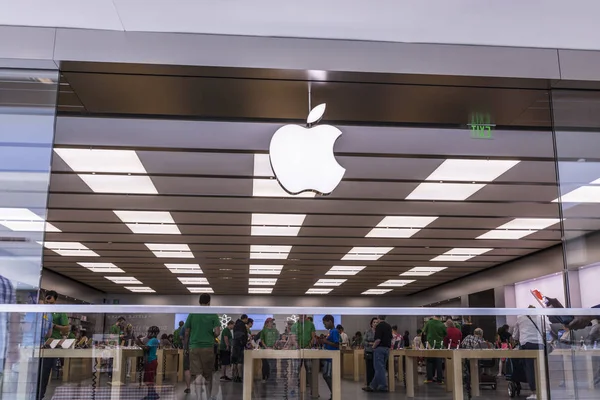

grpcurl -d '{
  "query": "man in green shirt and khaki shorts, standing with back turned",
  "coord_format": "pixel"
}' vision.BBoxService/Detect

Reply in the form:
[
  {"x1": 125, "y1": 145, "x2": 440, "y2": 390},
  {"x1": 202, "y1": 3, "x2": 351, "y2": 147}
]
[{"x1": 183, "y1": 293, "x2": 221, "y2": 398}]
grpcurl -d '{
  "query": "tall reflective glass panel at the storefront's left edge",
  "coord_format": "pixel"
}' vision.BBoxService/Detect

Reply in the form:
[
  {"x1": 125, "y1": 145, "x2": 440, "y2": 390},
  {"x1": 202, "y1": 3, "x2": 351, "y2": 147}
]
[{"x1": 0, "y1": 69, "x2": 58, "y2": 399}]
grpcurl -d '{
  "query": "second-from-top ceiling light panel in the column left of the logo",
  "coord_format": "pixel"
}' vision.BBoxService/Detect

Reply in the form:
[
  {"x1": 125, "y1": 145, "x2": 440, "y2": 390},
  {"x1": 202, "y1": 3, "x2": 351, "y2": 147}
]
[{"x1": 79, "y1": 174, "x2": 158, "y2": 194}]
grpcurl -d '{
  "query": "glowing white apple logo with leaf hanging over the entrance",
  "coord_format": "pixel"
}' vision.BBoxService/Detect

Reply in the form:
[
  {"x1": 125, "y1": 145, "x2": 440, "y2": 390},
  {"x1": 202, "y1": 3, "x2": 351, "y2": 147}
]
[{"x1": 269, "y1": 104, "x2": 346, "y2": 195}]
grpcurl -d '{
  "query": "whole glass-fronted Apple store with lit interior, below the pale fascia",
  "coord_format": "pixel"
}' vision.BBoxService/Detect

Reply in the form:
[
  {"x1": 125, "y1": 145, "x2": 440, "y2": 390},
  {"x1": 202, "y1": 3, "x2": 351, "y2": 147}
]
[{"x1": 0, "y1": 62, "x2": 600, "y2": 400}]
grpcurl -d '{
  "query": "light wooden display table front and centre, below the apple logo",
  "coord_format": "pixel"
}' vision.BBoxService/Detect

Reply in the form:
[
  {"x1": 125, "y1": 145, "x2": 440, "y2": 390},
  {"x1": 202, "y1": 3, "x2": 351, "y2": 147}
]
[{"x1": 243, "y1": 349, "x2": 342, "y2": 400}]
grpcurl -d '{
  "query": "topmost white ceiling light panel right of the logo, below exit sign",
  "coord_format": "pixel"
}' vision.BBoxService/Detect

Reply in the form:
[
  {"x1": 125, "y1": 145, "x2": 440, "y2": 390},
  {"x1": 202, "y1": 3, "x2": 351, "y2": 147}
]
[{"x1": 425, "y1": 159, "x2": 519, "y2": 182}]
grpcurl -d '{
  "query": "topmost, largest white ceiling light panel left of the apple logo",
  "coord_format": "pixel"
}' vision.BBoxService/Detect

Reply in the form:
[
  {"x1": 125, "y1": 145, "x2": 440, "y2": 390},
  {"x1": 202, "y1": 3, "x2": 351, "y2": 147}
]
[{"x1": 54, "y1": 148, "x2": 147, "y2": 174}]
